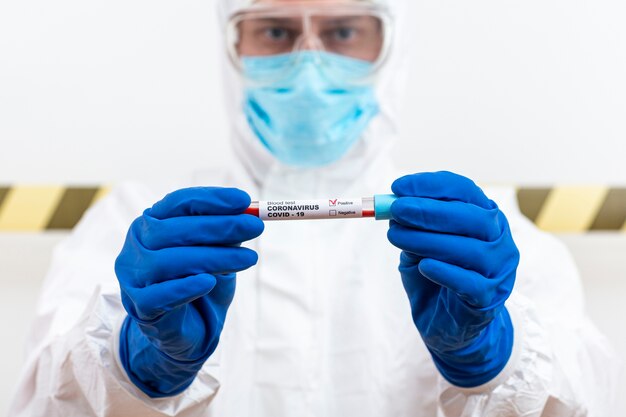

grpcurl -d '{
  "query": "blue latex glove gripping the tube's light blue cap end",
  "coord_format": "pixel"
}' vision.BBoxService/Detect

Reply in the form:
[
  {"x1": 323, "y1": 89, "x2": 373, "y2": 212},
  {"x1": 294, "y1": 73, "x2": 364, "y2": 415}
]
[{"x1": 388, "y1": 172, "x2": 519, "y2": 387}]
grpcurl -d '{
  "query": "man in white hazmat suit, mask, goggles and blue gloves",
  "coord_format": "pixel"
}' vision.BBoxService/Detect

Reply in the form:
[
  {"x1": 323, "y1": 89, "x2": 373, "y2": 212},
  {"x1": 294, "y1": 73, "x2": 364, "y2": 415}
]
[{"x1": 11, "y1": 0, "x2": 613, "y2": 416}]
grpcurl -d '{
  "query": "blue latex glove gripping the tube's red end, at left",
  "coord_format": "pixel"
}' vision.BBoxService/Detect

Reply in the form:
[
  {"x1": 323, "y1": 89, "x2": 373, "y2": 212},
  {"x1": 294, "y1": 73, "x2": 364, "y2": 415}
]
[{"x1": 115, "y1": 188, "x2": 263, "y2": 397}]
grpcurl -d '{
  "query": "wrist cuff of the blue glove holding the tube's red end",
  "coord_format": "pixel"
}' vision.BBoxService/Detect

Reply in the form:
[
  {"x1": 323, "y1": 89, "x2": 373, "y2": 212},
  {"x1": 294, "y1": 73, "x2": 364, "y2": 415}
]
[{"x1": 119, "y1": 316, "x2": 213, "y2": 398}]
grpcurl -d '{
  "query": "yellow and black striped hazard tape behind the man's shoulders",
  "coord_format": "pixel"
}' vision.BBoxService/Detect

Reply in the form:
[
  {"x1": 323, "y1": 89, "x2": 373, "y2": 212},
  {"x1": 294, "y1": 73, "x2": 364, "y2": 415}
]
[{"x1": 0, "y1": 186, "x2": 626, "y2": 233}]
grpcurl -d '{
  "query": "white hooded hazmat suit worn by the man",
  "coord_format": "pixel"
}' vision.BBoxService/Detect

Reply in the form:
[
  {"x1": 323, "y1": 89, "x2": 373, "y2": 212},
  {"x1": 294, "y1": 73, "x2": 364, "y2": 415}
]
[{"x1": 10, "y1": 0, "x2": 616, "y2": 417}]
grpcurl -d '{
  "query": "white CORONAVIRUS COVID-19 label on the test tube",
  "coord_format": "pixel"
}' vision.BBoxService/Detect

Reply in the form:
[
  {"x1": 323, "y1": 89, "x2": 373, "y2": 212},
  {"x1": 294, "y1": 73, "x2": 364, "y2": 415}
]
[{"x1": 259, "y1": 197, "x2": 363, "y2": 220}]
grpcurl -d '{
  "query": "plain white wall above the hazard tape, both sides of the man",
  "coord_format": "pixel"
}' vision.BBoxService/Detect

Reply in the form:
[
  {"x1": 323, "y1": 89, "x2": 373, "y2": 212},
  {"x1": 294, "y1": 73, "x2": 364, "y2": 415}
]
[{"x1": 0, "y1": 0, "x2": 626, "y2": 184}]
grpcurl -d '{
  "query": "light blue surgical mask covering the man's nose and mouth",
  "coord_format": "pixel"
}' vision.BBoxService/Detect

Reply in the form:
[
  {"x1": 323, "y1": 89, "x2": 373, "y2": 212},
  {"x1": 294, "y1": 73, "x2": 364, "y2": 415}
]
[{"x1": 243, "y1": 51, "x2": 379, "y2": 167}]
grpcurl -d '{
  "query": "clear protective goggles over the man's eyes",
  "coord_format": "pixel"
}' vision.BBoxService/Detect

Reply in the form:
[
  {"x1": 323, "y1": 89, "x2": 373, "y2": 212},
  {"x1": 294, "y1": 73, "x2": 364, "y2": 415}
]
[{"x1": 226, "y1": 1, "x2": 391, "y2": 82}]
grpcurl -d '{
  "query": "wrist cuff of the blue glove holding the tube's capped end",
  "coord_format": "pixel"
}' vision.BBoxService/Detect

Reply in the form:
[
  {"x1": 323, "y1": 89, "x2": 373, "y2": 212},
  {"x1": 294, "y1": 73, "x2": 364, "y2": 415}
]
[{"x1": 428, "y1": 308, "x2": 514, "y2": 388}]
